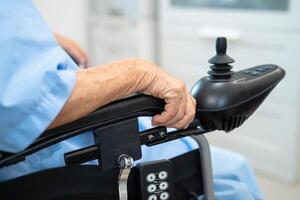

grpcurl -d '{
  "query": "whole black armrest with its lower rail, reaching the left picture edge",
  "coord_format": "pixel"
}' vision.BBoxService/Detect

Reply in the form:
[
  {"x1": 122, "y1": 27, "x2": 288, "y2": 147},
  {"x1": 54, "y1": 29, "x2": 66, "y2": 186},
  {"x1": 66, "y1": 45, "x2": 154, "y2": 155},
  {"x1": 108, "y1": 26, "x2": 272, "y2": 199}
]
[{"x1": 0, "y1": 94, "x2": 165, "y2": 168}]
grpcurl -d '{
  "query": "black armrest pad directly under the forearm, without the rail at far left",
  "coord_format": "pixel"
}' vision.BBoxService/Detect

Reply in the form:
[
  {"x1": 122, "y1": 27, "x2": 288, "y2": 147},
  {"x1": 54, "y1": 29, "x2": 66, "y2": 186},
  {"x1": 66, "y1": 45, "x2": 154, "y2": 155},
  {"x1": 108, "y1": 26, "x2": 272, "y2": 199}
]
[{"x1": 33, "y1": 94, "x2": 165, "y2": 145}]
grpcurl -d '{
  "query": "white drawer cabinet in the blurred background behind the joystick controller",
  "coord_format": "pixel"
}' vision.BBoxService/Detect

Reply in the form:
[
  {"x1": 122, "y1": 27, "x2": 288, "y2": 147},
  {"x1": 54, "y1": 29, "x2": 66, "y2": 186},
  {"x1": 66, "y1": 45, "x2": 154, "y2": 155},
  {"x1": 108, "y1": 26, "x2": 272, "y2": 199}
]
[{"x1": 160, "y1": 0, "x2": 300, "y2": 182}]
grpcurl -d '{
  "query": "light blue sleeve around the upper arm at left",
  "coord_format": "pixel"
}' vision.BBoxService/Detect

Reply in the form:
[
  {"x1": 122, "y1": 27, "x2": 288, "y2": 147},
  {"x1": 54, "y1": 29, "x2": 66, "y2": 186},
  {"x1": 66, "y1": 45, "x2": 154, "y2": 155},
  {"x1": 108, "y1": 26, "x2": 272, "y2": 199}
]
[{"x1": 0, "y1": 0, "x2": 77, "y2": 152}]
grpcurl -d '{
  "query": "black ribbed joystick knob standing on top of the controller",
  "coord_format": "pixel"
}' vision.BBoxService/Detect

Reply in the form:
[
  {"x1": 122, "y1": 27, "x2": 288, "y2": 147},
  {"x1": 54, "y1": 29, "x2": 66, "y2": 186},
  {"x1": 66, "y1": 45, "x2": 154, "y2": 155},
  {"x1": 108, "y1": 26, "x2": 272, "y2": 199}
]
[{"x1": 208, "y1": 37, "x2": 234, "y2": 79}]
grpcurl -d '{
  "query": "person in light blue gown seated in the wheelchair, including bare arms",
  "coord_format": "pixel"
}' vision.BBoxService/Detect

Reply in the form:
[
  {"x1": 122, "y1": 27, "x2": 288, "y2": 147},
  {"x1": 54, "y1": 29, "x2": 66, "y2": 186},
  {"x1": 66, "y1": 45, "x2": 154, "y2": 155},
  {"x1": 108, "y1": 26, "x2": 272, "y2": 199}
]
[{"x1": 0, "y1": 0, "x2": 259, "y2": 199}]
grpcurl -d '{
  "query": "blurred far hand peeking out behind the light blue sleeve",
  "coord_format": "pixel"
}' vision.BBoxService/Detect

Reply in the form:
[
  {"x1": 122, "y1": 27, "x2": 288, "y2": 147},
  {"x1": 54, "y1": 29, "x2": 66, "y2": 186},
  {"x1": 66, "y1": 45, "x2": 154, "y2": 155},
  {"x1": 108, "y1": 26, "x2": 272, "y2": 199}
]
[{"x1": 54, "y1": 33, "x2": 89, "y2": 68}]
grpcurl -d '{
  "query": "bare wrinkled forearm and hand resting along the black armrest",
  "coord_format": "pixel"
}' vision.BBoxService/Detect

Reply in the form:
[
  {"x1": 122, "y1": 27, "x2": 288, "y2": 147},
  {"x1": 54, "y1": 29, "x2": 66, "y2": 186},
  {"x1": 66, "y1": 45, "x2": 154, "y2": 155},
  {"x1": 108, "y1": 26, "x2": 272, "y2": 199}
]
[{"x1": 49, "y1": 59, "x2": 196, "y2": 129}]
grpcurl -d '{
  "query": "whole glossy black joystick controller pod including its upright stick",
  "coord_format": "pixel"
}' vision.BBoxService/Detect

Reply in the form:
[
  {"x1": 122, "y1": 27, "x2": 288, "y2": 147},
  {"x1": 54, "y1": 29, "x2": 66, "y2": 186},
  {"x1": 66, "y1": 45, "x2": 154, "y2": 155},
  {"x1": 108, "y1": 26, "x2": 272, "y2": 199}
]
[{"x1": 191, "y1": 37, "x2": 285, "y2": 132}]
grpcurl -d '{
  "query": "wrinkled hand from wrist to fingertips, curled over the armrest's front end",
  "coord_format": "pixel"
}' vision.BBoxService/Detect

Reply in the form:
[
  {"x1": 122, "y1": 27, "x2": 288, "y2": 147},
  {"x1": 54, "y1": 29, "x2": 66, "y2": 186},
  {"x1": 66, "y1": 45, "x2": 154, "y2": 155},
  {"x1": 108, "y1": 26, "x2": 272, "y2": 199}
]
[{"x1": 139, "y1": 60, "x2": 196, "y2": 129}]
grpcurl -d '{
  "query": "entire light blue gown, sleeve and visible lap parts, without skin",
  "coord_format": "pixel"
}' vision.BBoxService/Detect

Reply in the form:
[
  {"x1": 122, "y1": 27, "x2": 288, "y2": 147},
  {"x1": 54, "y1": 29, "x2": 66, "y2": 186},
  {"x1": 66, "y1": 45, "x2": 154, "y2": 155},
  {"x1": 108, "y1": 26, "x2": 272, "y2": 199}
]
[{"x1": 0, "y1": 0, "x2": 261, "y2": 200}]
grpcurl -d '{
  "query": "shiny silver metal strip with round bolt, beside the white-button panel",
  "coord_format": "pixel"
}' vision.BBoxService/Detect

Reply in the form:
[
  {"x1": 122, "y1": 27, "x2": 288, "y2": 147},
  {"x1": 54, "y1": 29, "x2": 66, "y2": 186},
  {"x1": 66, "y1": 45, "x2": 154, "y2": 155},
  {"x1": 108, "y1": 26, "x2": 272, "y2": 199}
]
[{"x1": 118, "y1": 154, "x2": 133, "y2": 200}]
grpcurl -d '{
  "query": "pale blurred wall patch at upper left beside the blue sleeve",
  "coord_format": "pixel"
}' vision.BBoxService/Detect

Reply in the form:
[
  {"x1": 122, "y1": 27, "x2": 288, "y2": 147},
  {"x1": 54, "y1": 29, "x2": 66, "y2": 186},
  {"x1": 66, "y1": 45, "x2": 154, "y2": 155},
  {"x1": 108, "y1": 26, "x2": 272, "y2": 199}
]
[{"x1": 33, "y1": 0, "x2": 89, "y2": 49}]
